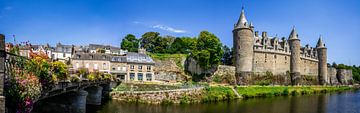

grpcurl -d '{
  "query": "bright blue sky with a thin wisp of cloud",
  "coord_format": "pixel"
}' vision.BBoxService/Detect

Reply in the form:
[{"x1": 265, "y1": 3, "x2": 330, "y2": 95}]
[{"x1": 0, "y1": 0, "x2": 360, "y2": 65}]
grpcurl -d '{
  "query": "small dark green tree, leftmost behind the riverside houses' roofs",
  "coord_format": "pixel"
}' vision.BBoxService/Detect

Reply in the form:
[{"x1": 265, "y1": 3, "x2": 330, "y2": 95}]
[{"x1": 120, "y1": 34, "x2": 139, "y2": 52}]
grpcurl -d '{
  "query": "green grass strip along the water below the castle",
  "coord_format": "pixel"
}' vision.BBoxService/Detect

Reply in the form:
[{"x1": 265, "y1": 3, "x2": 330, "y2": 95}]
[{"x1": 236, "y1": 86, "x2": 351, "y2": 98}]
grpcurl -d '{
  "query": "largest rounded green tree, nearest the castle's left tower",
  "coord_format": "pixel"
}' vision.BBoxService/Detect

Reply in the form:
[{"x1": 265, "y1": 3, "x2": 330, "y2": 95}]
[{"x1": 191, "y1": 31, "x2": 223, "y2": 69}]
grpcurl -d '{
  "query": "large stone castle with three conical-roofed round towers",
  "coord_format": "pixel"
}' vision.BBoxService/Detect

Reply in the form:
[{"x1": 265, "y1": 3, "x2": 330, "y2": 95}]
[{"x1": 233, "y1": 9, "x2": 328, "y2": 85}]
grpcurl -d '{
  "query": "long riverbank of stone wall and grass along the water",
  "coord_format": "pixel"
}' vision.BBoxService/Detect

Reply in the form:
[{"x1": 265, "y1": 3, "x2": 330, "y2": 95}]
[{"x1": 110, "y1": 86, "x2": 354, "y2": 104}]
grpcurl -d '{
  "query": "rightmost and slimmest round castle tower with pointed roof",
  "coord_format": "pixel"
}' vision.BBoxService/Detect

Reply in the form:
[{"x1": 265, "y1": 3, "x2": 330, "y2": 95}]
[{"x1": 316, "y1": 35, "x2": 328, "y2": 85}]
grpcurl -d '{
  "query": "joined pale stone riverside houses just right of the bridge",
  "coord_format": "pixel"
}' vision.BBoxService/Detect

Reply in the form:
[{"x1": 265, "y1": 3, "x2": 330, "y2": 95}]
[{"x1": 71, "y1": 50, "x2": 155, "y2": 82}]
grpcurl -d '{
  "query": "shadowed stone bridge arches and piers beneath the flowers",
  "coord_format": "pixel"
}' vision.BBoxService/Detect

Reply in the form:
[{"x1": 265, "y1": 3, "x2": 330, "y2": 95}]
[{"x1": 34, "y1": 81, "x2": 117, "y2": 113}]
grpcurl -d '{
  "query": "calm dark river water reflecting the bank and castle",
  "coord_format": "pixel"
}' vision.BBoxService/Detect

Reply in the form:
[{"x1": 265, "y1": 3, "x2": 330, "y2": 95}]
[{"x1": 87, "y1": 91, "x2": 360, "y2": 113}]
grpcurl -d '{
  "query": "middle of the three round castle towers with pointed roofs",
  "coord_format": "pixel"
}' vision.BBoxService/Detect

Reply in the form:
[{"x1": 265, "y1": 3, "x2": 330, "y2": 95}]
[{"x1": 288, "y1": 27, "x2": 301, "y2": 85}]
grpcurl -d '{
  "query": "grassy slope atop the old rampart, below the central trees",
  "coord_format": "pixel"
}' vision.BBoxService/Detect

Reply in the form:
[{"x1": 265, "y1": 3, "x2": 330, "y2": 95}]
[{"x1": 149, "y1": 53, "x2": 188, "y2": 69}]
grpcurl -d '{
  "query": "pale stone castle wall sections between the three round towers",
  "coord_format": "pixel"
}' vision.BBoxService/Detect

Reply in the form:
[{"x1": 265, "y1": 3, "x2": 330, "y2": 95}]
[{"x1": 253, "y1": 50, "x2": 318, "y2": 76}]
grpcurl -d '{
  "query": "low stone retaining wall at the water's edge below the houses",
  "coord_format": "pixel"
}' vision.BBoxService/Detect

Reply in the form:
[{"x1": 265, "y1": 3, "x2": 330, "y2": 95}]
[{"x1": 110, "y1": 88, "x2": 203, "y2": 104}]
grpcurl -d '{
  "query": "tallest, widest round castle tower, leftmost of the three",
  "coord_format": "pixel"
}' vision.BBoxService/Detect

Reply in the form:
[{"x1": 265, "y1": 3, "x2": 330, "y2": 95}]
[{"x1": 233, "y1": 8, "x2": 254, "y2": 85}]
